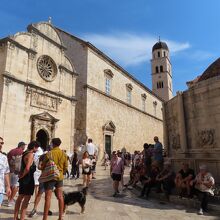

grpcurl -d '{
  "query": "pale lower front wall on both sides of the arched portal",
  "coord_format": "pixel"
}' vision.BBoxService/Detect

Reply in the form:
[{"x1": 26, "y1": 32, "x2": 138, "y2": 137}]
[{"x1": 0, "y1": 81, "x2": 75, "y2": 152}]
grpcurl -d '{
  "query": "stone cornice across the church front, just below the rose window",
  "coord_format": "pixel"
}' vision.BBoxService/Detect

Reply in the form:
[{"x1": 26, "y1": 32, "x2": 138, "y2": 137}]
[{"x1": 2, "y1": 72, "x2": 77, "y2": 102}]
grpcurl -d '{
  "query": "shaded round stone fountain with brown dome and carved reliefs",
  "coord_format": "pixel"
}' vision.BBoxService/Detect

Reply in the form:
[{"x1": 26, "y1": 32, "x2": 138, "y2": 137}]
[{"x1": 164, "y1": 59, "x2": 220, "y2": 182}]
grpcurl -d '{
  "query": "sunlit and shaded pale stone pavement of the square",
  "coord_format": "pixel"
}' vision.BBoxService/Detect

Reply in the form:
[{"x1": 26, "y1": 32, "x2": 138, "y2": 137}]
[{"x1": 0, "y1": 166, "x2": 220, "y2": 220}]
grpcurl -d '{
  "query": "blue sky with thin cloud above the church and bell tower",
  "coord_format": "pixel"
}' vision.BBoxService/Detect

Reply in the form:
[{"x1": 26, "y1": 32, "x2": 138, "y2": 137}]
[{"x1": 0, "y1": 0, "x2": 220, "y2": 94}]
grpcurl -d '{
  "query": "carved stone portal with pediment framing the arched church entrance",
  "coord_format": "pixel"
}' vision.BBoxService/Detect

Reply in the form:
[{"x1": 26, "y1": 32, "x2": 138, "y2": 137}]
[{"x1": 31, "y1": 112, "x2": 59, "y2": 143}]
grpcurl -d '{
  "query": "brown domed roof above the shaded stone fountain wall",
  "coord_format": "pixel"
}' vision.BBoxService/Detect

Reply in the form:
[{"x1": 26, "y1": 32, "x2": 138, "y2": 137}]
[{"x1": 198, "y1": 58, "x2": 220, "y2": 82}]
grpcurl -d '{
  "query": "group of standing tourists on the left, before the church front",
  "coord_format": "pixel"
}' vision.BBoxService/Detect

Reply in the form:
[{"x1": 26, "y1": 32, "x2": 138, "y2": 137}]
[{"x1": 0, "y1": 137, "x2": 97, "y2": 220}]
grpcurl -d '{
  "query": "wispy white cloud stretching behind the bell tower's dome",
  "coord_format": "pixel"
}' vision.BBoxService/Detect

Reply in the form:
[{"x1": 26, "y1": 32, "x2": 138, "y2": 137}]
[{"x1": 82, "y1": 32, "x2": 190, "y2": 66}]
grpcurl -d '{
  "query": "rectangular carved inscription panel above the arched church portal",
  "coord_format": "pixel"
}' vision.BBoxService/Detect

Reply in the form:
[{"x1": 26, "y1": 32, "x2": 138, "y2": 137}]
[{"x1": 31, "y1": 90, "x2": 62, "y2": 112}]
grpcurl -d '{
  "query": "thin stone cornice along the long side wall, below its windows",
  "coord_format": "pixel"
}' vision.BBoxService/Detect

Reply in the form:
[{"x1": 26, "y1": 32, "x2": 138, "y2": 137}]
[{"x1": 84, "y1": 84, "x2": 163, "y2": 122}]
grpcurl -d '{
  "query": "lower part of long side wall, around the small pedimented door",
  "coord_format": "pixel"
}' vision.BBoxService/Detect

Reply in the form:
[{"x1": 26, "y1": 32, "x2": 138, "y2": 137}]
[{"x1": 87, "y1": 88, "x2": 163, "y2": 160}]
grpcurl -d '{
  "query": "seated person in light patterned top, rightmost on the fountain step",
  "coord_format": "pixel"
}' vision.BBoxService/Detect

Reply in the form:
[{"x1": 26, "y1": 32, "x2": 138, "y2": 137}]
[{"x1": 191, "y1": 165, "x2": 215, "y2": 215}]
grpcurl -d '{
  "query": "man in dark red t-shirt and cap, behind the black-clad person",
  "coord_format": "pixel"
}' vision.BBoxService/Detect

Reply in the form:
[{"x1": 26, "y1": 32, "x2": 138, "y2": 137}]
[{"x1": 7, "y1": 141, "x2": 26, "y2": 207}]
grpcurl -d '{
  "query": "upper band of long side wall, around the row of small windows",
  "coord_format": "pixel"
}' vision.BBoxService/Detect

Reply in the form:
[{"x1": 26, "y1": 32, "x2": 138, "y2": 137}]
[{"x1": 87, "y1": 49, "x2": 162, "y2": 120}]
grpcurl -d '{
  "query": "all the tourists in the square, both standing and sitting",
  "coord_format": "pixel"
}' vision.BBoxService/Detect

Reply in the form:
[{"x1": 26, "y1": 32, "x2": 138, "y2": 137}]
[{"x1": 0, "y1": 137, "x2": 215, "y2": 220}]
